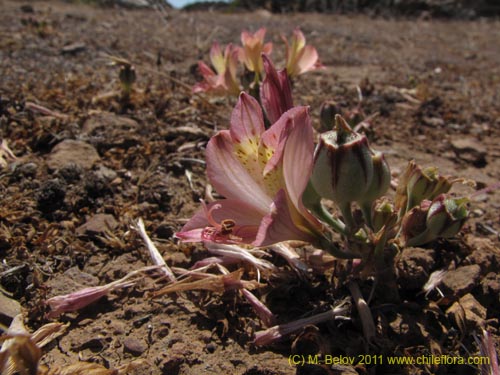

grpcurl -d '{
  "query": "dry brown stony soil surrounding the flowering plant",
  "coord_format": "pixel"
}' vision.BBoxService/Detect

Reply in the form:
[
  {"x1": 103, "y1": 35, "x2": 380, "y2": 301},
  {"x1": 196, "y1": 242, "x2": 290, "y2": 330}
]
[{"x1": 0, "y1": 0, "x2": 500, "y2": 375}]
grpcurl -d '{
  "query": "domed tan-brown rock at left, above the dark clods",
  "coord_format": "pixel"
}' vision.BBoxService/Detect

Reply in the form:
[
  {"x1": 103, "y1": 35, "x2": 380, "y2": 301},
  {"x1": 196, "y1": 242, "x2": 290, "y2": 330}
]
[{"x1": 47, "y1": 139, "x2": 100, "y2": 170}]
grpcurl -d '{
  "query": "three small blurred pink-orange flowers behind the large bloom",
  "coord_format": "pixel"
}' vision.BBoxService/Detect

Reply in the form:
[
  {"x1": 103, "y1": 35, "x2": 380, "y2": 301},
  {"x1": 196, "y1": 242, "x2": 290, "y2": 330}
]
[{"x1": 193, "y1": 28, "x2": 322, "y2": 95}]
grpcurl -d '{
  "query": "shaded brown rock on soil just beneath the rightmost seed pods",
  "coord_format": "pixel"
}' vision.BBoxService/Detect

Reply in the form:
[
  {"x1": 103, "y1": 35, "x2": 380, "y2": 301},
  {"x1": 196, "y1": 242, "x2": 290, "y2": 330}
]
[{"x1": 396, "y1": 247, "x2": 436, "y2": 290}]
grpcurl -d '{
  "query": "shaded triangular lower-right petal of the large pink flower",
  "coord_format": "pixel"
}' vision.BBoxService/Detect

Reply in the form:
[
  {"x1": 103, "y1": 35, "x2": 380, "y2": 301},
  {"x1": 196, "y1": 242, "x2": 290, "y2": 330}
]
[{"x1": 253, "y1": 189, "x2": 312, "y2": 246}]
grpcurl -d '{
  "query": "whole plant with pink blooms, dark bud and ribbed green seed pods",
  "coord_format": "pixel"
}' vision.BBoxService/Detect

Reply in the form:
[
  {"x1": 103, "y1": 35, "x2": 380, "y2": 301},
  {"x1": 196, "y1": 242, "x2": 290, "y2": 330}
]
[{"x1": 180, "y1": 25, "x2": 468, "y2": 268}]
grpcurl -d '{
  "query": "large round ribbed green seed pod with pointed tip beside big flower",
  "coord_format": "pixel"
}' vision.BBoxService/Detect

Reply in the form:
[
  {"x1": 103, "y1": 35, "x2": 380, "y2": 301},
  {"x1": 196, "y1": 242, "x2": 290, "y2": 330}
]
[{"x1": 311, "y1": 115, "x2": 373, "y2": 205}]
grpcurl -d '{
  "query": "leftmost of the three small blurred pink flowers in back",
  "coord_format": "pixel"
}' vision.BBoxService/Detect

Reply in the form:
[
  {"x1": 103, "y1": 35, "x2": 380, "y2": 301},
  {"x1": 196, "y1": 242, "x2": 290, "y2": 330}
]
[{"x1": 193, "y1": 42, "x2": 240, "y2": 95}]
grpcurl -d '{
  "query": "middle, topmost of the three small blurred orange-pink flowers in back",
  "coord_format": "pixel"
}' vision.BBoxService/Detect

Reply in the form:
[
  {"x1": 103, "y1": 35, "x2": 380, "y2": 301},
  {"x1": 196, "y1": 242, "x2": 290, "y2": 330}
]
[{"x1": 239, "y1": 28, "x2": 273, "y2": 77}]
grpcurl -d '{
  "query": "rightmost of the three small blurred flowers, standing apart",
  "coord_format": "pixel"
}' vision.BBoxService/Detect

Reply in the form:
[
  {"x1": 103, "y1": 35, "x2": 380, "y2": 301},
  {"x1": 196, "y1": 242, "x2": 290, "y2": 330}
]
[{"x1": 283, "y1": 28, "x2": 323, "y2": 77}]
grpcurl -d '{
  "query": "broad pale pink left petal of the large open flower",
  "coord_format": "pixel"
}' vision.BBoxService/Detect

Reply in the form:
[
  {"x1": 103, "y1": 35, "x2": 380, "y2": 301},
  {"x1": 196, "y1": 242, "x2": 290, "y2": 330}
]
[{"x1": 206, "y1": 130, "x2": 271, "y2": 214}]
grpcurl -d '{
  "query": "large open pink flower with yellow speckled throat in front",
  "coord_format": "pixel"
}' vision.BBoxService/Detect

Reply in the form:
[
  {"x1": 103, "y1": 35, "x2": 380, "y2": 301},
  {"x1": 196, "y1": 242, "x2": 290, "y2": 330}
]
[{"x1": 176, "y1": 93, "x2": 323, "y2": 246}]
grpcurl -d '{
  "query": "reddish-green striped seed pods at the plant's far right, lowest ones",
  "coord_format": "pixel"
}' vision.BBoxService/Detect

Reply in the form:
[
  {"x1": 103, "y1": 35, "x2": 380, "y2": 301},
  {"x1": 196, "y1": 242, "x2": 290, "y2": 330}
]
[{"x1": 401, "y1": 194, "x2": 469, "y2": 246}]
